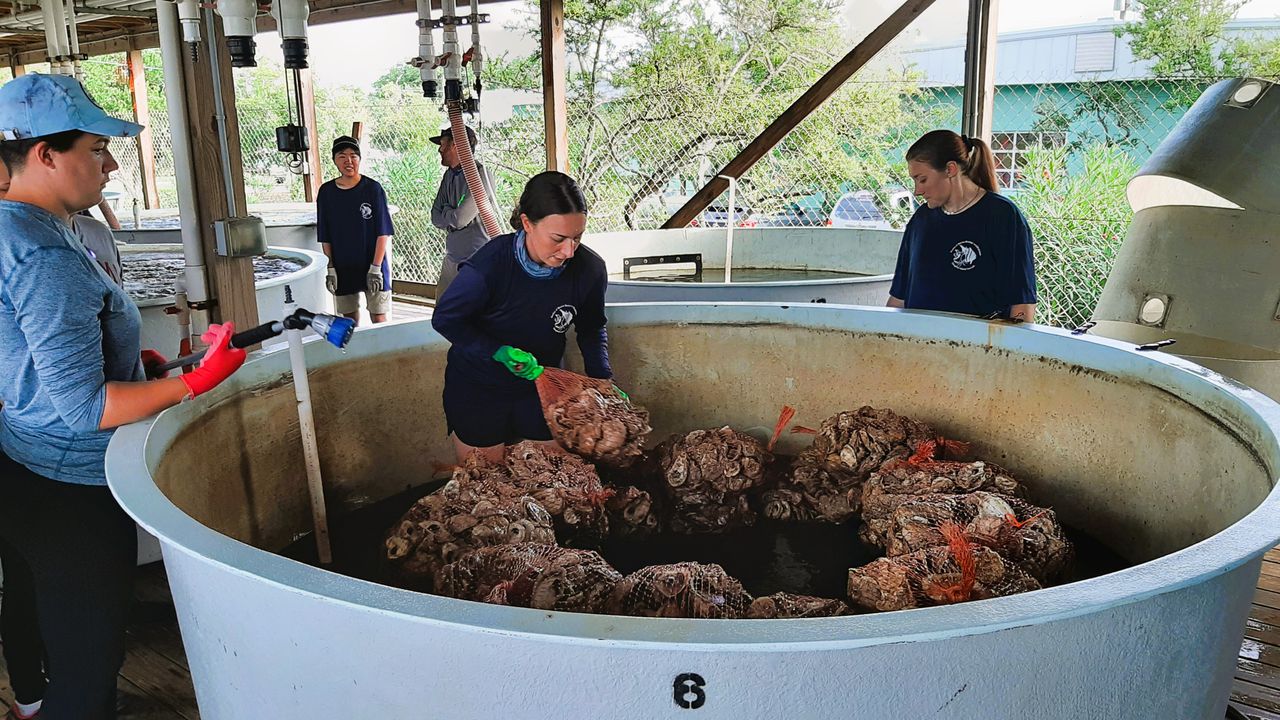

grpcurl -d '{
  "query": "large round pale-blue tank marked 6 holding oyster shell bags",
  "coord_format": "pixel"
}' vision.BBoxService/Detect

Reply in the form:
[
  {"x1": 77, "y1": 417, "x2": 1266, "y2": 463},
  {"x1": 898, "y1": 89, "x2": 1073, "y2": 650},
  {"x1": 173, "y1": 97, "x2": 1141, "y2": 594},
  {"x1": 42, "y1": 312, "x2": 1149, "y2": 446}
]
[{"x1": 108, "y1": 302, "x2": 1280, "y2": 720}]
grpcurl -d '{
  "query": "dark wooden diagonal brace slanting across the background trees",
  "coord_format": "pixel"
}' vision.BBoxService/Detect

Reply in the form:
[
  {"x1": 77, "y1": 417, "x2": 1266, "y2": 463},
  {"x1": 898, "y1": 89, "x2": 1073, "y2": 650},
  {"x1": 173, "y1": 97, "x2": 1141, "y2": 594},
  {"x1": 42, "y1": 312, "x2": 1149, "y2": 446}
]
[{"x1": 662, "y1": 0, "x2": 933, "y2": 229}]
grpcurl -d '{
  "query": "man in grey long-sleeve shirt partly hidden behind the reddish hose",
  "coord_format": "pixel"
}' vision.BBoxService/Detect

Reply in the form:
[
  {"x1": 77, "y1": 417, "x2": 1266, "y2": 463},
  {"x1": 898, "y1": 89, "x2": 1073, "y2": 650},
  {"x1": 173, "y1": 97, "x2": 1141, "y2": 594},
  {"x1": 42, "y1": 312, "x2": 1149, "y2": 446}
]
[{"x1": 431, "y1": 128, "x2": 500, "y2": 300}]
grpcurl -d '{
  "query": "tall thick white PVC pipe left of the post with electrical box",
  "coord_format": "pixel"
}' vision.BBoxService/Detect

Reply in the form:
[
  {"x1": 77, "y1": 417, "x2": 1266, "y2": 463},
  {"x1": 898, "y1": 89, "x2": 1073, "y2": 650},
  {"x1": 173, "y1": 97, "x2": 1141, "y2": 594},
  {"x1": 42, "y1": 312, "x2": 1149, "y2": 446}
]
[{"x1": 156, "y1": 3, "x2": 209, "y2": 302}]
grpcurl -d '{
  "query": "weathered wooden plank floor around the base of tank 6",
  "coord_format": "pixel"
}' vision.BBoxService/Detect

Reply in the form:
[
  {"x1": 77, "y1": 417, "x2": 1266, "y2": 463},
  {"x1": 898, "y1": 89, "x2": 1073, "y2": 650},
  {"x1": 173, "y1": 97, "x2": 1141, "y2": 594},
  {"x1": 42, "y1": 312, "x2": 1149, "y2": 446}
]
[{"x1": 0, "y1": 515, "x2": 1280, "y2": 720}]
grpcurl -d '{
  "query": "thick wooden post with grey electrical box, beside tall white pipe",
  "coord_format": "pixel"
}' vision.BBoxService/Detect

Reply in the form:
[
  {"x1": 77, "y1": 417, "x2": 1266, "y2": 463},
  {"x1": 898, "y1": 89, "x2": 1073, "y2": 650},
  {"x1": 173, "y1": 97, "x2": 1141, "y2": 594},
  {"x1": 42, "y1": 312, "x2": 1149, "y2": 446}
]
[{"x1": 179, "y1": 14, "x2": 259, "y2": 329}]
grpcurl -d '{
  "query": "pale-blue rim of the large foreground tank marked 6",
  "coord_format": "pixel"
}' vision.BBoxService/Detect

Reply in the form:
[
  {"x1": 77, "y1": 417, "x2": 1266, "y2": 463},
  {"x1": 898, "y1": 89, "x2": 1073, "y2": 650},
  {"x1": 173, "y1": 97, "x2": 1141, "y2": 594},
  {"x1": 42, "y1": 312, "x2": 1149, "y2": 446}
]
[{"x1": 106, "y1": 302, "x2": 1280, "y2": 652}]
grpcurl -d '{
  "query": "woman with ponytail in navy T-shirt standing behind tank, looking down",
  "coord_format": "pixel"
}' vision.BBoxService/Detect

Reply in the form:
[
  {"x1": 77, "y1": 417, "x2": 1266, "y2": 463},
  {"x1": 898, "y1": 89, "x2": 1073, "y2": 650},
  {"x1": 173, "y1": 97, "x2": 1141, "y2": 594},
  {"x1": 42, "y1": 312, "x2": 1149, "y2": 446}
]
[{"x1": 888, "y1": 129, "x2": 1036, "y2": 322}]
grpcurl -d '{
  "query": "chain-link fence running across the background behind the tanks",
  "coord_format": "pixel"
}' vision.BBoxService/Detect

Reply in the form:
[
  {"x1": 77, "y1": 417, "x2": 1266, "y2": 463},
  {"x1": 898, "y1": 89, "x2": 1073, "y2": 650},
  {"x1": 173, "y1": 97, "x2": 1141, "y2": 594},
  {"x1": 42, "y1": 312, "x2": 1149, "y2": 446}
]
[{"x1": 82, "y1": 25, "x2": 1228, "y2": 325}]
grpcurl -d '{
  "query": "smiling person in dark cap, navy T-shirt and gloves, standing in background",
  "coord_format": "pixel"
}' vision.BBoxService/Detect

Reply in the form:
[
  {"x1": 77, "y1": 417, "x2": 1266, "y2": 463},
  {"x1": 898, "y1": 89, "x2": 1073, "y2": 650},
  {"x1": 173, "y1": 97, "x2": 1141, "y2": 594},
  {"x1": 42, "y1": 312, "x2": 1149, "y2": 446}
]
[{"x1": 316, "y1": 136, "x2": 394, "y2": 323}]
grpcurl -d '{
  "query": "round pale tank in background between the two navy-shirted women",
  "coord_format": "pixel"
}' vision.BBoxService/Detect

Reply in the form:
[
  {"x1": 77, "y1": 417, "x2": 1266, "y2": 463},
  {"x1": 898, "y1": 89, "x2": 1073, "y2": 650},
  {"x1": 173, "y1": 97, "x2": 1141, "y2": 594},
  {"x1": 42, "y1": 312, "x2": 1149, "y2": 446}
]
[{"x1": 584, "y1": 228, "x2": 902, "y2": 305}]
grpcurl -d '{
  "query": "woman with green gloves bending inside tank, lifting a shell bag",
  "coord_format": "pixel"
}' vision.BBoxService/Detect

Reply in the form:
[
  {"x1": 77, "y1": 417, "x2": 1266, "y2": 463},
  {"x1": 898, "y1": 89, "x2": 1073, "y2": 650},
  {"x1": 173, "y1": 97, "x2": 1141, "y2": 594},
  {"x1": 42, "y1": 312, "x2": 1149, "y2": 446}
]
[{"x1": 431, "y1": 170, "x2": 613, "y2": 462}]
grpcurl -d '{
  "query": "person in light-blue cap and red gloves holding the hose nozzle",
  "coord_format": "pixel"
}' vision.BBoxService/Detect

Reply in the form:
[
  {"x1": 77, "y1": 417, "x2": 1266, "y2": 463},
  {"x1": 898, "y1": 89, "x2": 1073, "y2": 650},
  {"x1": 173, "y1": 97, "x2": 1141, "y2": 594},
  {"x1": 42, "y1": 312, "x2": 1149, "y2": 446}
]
[{"x1": 0, "y1": 74, "x2": 244, "y2": 720}]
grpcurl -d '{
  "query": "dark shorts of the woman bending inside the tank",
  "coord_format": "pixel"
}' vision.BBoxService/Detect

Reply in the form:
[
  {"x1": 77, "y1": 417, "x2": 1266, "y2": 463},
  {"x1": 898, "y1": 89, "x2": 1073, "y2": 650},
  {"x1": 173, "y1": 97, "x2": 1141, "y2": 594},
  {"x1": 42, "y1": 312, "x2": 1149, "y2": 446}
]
[{"x1": 444, "y1": 378, "x2": 552, "y2": 447}]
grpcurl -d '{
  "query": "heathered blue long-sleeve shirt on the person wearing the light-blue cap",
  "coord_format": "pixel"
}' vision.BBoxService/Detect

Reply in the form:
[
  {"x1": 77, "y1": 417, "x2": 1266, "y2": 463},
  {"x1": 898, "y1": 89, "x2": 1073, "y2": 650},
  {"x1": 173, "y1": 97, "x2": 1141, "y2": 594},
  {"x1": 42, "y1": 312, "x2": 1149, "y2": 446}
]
[{"x1": 0, "y1": 200, "x2": 143, "y2": 484}]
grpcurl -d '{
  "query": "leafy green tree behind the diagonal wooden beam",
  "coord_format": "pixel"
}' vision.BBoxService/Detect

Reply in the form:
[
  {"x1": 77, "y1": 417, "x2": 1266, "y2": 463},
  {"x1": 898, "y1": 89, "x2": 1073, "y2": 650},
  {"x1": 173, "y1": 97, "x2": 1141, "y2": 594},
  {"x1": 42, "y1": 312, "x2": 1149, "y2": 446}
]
[{"x1": 486, "y1": 0, "x2": 914, "y2": 228}]
